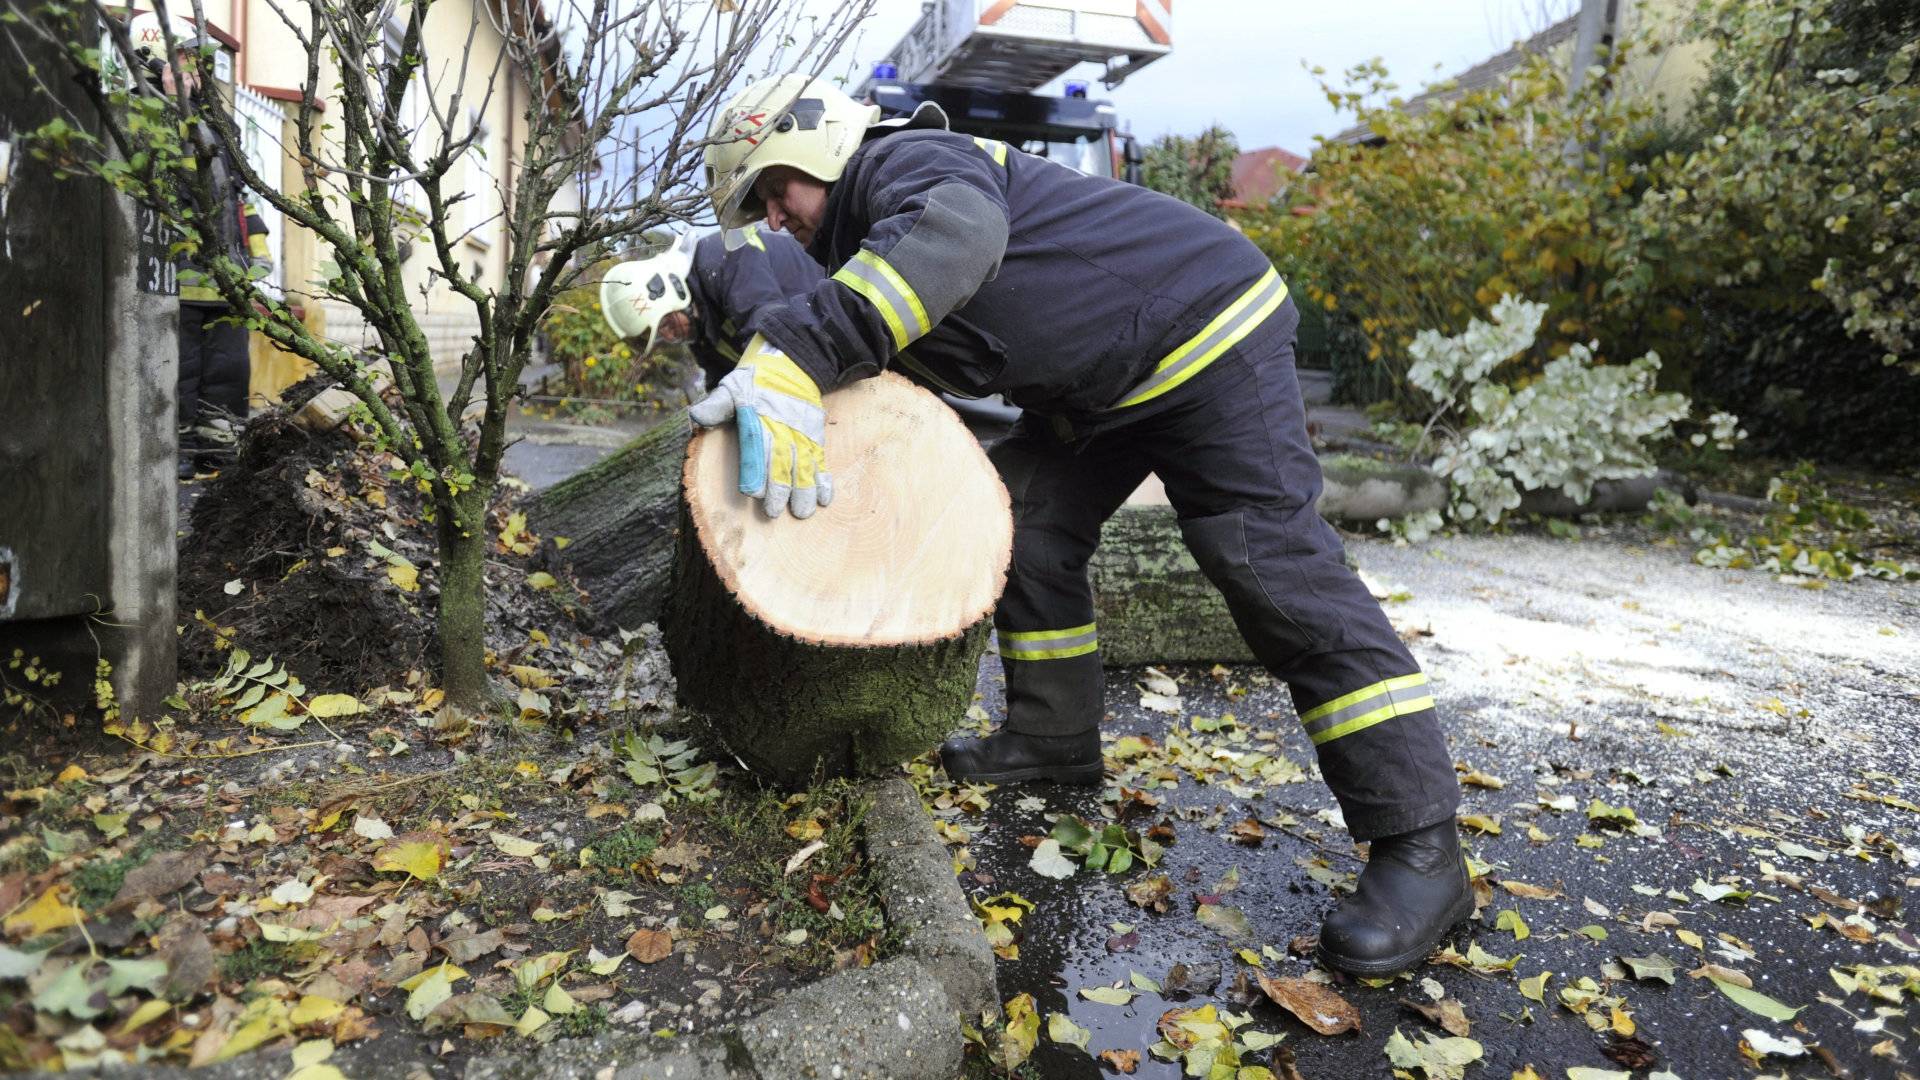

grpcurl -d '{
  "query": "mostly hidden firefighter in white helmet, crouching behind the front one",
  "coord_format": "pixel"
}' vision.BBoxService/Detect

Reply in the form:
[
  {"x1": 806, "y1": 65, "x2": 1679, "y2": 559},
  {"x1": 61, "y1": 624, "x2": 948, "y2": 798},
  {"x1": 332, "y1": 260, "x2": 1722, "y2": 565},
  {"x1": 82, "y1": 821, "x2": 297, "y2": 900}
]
[{"x1": 601, "y1": 223, "x2": 826, "y2": 390}]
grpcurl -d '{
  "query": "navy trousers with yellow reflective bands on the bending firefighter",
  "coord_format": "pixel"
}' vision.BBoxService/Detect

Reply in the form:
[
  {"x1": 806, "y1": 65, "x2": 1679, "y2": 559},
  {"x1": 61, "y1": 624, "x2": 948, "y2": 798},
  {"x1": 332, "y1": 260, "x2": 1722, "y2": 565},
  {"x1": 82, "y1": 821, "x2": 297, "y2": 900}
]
[{"x1": 989, "y1": 302, "x2": 1459, "y2": 840}]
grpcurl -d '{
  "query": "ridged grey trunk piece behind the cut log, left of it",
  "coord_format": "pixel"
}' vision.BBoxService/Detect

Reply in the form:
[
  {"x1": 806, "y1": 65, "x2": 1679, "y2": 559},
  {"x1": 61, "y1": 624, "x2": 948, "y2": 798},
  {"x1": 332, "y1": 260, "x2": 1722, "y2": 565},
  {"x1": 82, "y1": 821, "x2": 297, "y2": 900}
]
[{"x1": 528, "y1": 413, "x2": 693, "y2": 628}]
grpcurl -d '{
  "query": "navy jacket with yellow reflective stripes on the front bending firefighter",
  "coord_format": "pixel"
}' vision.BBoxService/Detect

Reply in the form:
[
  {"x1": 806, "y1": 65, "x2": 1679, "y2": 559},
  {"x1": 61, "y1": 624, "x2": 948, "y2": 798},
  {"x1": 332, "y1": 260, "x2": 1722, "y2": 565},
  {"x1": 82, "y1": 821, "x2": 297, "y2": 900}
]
[{"x1": 755, "y1": 106, "x2": 1286, "y2": 429}]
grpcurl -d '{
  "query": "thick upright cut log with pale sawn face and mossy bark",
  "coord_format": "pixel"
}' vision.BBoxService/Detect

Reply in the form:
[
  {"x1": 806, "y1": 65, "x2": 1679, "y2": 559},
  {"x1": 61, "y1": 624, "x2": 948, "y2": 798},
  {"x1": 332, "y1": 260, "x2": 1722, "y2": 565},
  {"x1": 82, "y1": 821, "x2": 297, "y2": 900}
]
[{"x1": 664, "y1": 375, "x2": 1014, "y2": 786}]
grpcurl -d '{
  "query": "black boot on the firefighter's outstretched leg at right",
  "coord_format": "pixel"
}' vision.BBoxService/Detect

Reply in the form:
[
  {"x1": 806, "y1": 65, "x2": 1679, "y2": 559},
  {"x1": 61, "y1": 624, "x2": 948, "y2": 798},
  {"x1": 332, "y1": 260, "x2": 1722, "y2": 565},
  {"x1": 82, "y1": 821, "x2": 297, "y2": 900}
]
[{"x1": 1319, "y1": 819, "x2": 1473, "y2": 976}]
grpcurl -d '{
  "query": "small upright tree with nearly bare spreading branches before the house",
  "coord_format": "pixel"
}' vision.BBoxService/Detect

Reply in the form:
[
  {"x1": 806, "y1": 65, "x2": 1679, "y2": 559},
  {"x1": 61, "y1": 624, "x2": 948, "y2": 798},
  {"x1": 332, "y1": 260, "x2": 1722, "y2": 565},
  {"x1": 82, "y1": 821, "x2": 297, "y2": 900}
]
[{"x1": 4, "y1": 0, "x2": 872, "y2": 705}]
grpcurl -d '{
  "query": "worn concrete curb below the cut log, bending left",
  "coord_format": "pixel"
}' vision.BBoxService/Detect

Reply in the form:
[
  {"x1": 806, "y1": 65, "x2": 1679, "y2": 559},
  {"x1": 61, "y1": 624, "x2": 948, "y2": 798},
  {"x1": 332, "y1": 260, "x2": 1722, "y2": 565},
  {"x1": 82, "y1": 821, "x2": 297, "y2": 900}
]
[{"x1": 78, "y1": 778, "x2": 998, "y2": 1080}]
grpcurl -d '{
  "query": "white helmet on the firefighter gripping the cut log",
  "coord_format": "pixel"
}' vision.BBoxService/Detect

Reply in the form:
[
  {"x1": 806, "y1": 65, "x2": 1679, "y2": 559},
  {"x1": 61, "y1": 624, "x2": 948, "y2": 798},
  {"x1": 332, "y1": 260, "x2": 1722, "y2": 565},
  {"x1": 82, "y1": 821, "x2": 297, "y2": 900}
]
[{"x1": 707, "y1": 75, "x2": 879, "y2": 229}]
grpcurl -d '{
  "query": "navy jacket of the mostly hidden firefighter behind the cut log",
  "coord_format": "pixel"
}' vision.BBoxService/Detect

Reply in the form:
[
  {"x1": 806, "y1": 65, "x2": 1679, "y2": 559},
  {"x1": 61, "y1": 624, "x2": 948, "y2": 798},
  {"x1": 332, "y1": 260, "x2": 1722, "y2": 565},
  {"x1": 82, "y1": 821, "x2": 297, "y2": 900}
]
[{"x1": 687, "y1": 225, "x2": 828, "y2": 390}]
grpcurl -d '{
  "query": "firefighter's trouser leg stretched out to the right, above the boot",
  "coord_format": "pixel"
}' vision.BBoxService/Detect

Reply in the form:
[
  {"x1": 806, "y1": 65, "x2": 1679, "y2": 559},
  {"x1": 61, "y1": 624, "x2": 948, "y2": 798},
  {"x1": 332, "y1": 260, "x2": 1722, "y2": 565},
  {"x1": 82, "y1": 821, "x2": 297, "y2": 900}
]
[{"x1": 1133, "y1": 319, "x2": 1459, "y2": 840}]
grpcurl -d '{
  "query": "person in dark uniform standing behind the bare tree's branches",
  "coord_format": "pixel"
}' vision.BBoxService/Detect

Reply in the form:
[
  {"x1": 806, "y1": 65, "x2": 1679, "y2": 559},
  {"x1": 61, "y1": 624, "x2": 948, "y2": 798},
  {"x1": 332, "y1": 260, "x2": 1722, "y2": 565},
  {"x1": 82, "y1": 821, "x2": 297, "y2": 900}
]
[{"x1": 127, "y1": 12, "x2": 273, "y2": 477}]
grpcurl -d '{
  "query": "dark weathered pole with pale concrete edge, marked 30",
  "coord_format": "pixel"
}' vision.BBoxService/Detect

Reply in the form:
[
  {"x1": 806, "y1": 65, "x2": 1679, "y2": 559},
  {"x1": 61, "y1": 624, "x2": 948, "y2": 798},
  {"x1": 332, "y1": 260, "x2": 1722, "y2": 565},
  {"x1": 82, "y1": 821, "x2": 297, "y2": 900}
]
[{"x1": 0, "y1": 23, "x2": 179, "y2": 724}]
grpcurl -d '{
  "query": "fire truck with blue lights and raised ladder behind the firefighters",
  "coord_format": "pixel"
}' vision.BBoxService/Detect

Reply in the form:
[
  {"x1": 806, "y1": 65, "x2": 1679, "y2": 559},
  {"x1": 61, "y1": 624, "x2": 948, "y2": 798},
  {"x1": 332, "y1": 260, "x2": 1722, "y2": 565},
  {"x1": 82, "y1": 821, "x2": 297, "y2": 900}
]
[{"x1": 854, "y1": 0, "x2": 1173, "y2": 183}]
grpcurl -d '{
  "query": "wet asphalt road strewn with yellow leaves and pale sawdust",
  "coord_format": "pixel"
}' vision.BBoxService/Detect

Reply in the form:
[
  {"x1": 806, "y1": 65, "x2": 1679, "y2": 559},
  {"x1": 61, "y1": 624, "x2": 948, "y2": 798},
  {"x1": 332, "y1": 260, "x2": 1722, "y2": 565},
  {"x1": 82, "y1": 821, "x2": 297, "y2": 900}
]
[{"x1": 947, "y1": 528, "x2": 1920, "y2": 1080}]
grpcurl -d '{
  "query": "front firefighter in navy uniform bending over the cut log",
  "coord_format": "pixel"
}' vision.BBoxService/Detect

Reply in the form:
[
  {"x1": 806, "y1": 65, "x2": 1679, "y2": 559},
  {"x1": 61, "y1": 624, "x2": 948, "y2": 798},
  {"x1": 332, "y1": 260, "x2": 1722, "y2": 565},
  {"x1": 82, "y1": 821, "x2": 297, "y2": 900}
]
[{"x1": 693, "y1": 77, "x2": 1473, "y2": 974}]
